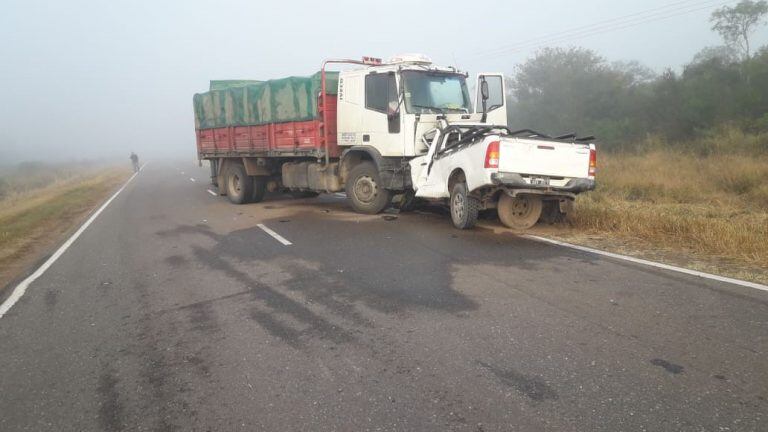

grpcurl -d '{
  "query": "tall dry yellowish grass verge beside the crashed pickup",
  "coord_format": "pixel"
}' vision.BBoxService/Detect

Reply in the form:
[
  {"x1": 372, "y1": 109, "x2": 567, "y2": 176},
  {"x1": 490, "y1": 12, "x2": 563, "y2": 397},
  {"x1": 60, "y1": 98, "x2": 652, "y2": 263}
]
[{"x1": 533, "y1": 130, "x2": 768, "y2": 283}]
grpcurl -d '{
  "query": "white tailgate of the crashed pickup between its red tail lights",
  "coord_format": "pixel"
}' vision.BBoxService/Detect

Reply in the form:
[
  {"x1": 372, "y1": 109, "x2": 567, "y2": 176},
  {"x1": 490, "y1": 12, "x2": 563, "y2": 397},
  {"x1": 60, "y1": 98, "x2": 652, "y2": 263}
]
[{"x1": 499, "y1": 138, "x2": 589, "y2": 178}]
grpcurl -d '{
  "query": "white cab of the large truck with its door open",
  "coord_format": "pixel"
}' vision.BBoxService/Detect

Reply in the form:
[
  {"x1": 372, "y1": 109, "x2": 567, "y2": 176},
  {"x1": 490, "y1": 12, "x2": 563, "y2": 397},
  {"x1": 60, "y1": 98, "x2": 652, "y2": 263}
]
[{"x1": 337, "y1": 54, "x2": 507, "y2": 158}]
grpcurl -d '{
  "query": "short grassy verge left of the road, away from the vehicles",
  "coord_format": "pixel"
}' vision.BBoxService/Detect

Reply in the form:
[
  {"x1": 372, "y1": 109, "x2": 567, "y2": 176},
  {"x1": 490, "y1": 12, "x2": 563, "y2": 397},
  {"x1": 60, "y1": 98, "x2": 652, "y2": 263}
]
[{"x1": 0, "y1": 168, "x2": 130, "y2": 289}]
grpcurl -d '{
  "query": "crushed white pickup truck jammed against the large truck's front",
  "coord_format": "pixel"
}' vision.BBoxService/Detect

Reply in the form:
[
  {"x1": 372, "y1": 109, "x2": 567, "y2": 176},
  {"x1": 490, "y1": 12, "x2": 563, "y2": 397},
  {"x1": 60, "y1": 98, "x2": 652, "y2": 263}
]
[{"x1": 410, "y1": 120, "x2": 597, "y2": 230}]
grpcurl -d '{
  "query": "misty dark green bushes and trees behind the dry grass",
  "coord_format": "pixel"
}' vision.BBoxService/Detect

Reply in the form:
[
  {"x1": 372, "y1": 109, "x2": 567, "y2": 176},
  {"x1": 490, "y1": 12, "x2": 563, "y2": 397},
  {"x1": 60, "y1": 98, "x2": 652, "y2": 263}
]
[{"x1": 509, "y1": 47, "x2": 768, "y2": 153}]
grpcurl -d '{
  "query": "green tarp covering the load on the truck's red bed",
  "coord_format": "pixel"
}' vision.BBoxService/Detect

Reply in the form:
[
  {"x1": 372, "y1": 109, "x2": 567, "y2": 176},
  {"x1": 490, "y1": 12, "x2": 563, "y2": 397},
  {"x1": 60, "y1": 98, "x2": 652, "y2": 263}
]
[{"x1": 193, "y1": 72, "x2": 339, "y2": 129}]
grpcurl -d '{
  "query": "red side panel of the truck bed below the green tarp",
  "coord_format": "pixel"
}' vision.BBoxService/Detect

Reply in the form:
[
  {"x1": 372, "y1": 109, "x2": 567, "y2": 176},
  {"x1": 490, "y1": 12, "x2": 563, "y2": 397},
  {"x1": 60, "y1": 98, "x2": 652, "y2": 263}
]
[{"x1": 196, "y1": 95, "x2": 341, "y2": 159}]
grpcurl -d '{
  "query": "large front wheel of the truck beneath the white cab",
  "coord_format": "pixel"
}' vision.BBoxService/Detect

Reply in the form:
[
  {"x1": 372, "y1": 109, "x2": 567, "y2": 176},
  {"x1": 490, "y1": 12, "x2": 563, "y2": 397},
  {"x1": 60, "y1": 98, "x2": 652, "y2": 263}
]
[{"x1": 344, "y1": 161, "x2": 392, "y2": 214}]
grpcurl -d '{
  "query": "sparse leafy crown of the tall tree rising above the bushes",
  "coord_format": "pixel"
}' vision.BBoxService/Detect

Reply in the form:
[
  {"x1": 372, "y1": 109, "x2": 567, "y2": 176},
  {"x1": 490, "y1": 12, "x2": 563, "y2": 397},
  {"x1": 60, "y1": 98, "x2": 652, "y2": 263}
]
[{"x1": 710, "y1": 0, "x2": 768, "y2": 59}]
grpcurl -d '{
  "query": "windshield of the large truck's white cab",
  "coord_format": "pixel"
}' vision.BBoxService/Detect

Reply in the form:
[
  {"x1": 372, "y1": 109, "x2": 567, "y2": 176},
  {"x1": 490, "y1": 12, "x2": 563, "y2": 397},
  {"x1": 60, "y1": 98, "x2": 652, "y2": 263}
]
[{"x1": 402, "y1": 71, "x2": 472, "y2": 114}]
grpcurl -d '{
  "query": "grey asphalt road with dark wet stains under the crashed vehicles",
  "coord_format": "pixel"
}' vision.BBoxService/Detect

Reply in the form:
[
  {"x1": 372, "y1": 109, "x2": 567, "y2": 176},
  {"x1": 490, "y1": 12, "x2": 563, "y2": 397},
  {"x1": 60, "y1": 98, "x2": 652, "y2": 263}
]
[{"x1": 0, "y1": 162, "x2": 768, "y2": 431}]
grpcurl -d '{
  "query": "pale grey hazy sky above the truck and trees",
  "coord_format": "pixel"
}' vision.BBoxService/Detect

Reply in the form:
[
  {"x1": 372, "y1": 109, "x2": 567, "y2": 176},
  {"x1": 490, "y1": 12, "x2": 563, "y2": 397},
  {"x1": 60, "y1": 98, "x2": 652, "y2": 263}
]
[{"x1": 0, "y1": 0, "x2": 768, "y2": 163}]
